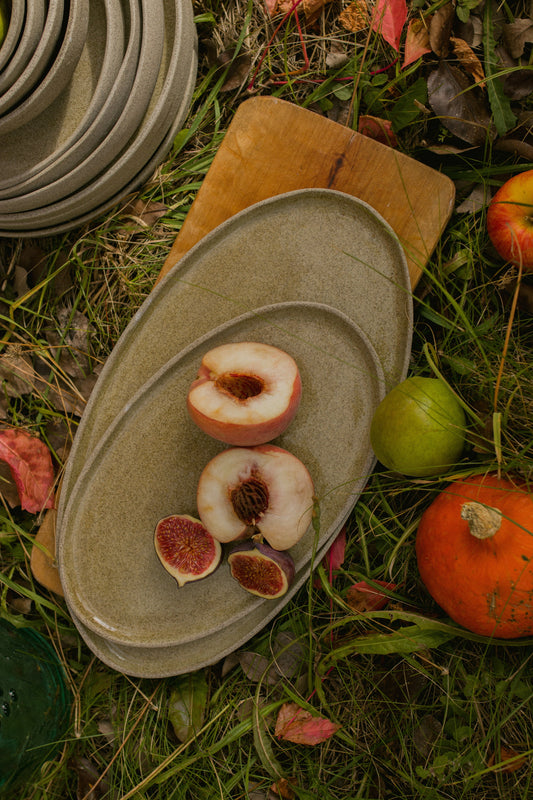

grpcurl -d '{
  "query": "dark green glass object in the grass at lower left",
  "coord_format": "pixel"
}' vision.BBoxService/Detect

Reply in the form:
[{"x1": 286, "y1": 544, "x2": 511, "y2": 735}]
[{"x1": 0, "y1": 619, "x2": 72, "y2": 797}]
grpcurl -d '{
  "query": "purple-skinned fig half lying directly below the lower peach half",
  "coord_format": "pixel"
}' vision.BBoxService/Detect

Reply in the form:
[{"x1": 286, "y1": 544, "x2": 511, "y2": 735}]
[{"x1": 228, "y1": 539, "x2": 295, "y2": 600}]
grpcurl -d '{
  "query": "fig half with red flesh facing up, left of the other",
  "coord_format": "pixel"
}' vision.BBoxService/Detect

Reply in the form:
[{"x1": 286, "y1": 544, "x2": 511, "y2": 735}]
[{"x1": 154, "y1": 514, "x2": 222, "y2": 586}]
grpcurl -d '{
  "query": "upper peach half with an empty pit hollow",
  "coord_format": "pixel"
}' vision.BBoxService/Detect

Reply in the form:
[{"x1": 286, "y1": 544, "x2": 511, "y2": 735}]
[{"x1": 187, "y1": 342, "x2": 302, "y2": 447}]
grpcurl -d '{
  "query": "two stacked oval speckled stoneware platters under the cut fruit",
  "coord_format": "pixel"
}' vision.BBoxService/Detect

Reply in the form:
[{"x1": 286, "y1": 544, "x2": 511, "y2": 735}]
[{"x1": 56, "y1": 189, "x2": 412, "y2": 678}]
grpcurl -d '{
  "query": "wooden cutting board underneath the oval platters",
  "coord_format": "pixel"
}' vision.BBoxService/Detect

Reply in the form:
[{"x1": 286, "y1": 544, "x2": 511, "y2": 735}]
[{"x1": 31, "y1": 97, "x2": 455, "y2": 593}]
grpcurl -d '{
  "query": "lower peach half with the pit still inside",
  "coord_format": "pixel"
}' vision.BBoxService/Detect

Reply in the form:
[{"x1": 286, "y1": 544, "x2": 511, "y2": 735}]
[{"x1": 196, "y1": 444, "x2": 314, "y2": 550}]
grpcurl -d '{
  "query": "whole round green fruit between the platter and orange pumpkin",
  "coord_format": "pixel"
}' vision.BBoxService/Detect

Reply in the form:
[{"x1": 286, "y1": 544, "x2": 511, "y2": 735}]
[{"x1": 370, "y1": 376, "x2": 466, "y2": 477}]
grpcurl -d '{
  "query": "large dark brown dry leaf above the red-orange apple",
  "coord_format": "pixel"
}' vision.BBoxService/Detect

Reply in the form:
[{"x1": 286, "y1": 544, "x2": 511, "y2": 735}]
[{"x1": 427, "y1": 61, "x2": 496, "y2": 145}]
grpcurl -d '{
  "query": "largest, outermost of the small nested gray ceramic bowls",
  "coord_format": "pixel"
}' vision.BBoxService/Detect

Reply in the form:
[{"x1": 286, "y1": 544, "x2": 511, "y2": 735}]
[{"x1": 0, "y1": 0, "x2": 89, "y2": 135}]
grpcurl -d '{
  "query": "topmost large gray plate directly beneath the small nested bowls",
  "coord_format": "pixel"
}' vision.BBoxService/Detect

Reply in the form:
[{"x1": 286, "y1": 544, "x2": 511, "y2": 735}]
[{"x1": 0, "y1": 0, "x2": 134, "y2": 200}]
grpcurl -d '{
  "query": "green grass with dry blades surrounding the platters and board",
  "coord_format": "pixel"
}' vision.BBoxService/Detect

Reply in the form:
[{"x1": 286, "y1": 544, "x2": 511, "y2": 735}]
[{"x1": 0, "y1": 0, "x2": 533, "y2": 800}]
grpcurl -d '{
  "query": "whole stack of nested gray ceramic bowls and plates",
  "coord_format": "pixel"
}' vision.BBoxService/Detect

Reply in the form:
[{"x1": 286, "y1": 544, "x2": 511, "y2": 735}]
[{"x1": 0, "y1": 0, "x2": 197, "y2": 237}]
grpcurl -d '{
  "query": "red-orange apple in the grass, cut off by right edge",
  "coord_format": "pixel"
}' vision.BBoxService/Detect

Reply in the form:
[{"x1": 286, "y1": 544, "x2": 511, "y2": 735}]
[{"x1": 487, "y1": 169, "x2": 533, "y2": 272}]
